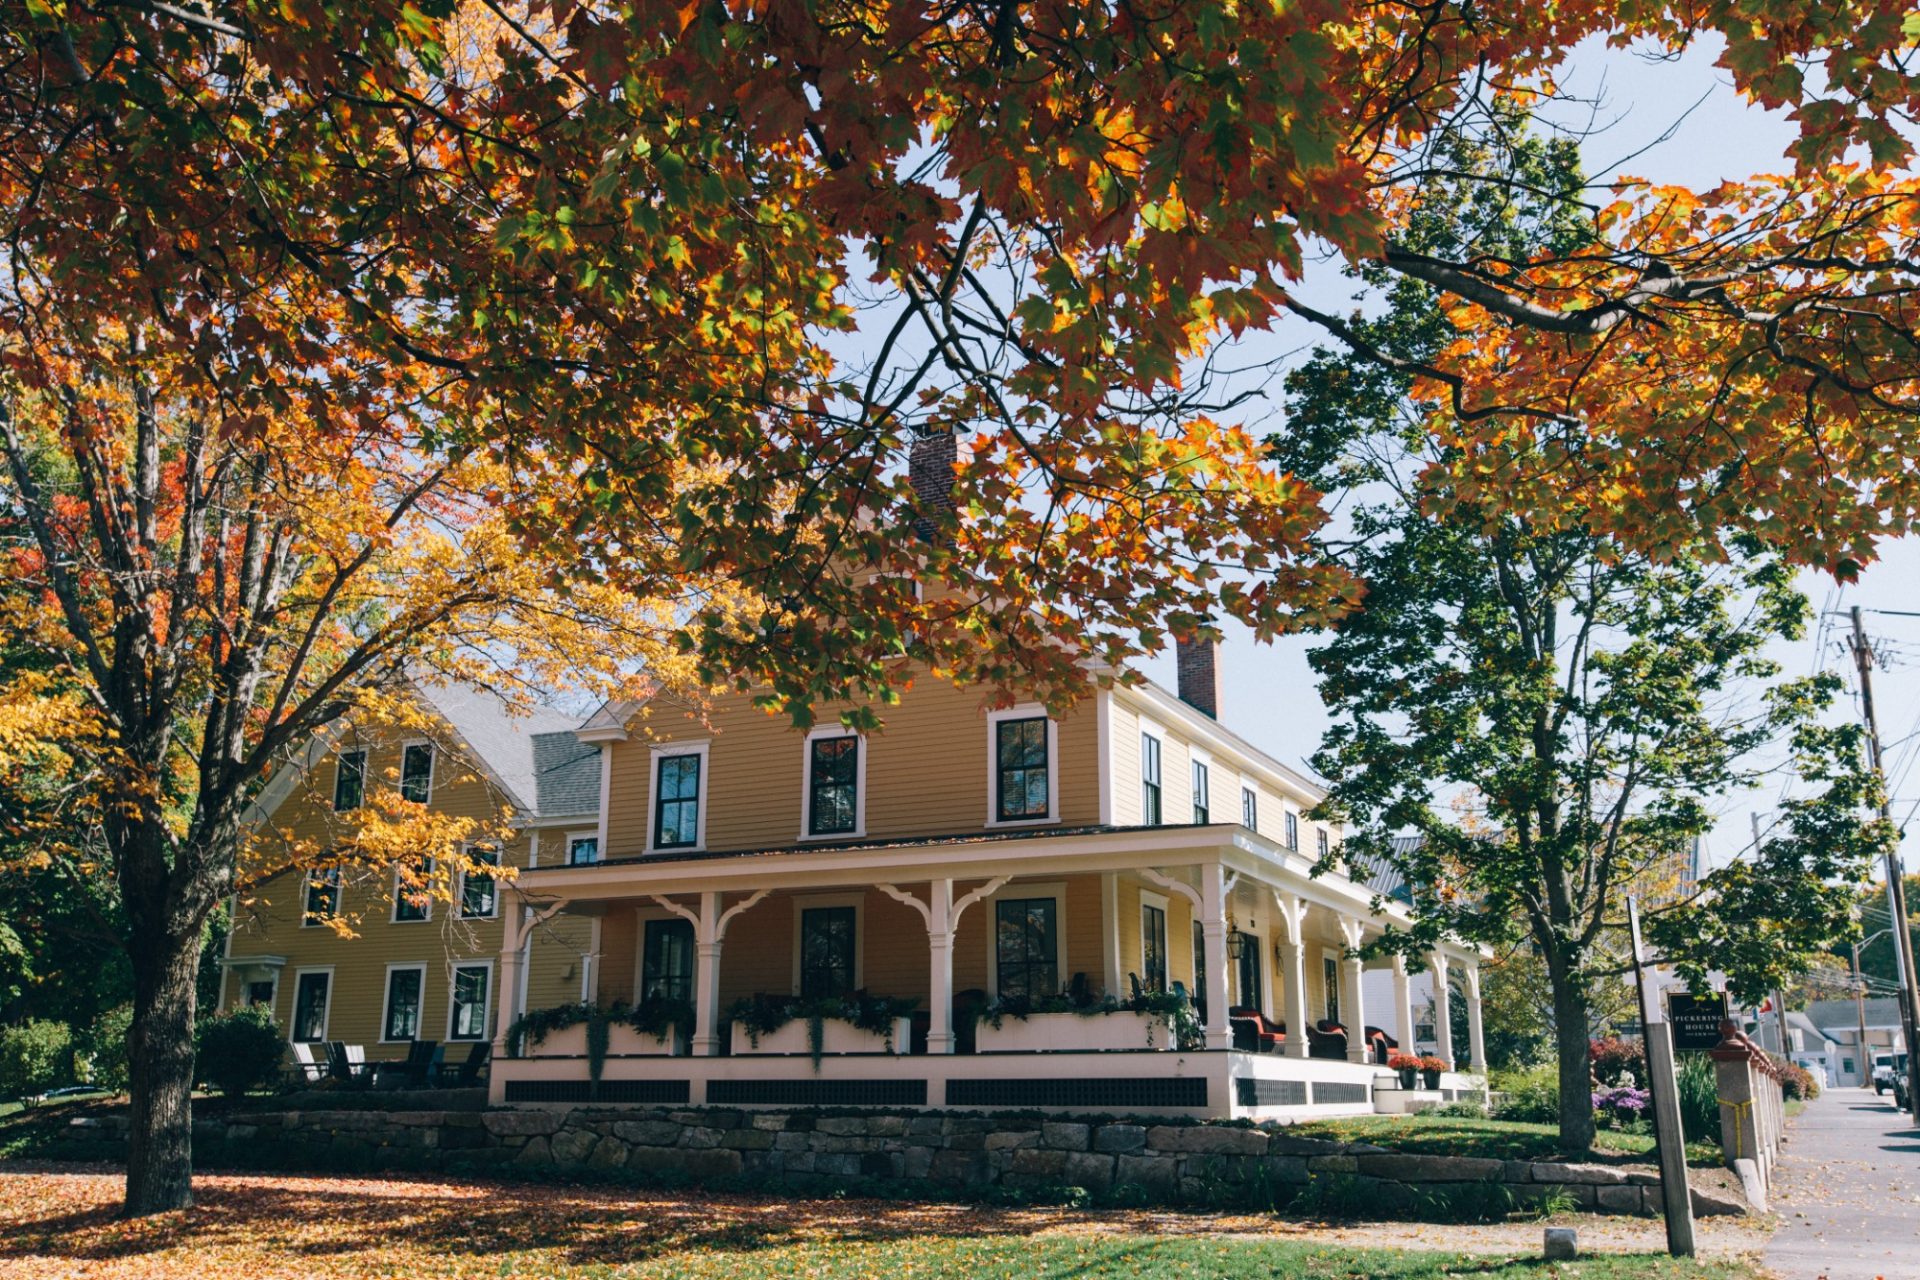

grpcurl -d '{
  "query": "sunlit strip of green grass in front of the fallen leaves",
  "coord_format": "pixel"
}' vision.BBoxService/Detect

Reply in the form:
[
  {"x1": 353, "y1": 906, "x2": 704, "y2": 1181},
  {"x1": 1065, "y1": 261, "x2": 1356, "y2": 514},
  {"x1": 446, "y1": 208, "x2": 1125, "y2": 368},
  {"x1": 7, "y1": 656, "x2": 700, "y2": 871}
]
[{"x1": 622, "y1": 1236, "x2": 1761, "y2": 1280}]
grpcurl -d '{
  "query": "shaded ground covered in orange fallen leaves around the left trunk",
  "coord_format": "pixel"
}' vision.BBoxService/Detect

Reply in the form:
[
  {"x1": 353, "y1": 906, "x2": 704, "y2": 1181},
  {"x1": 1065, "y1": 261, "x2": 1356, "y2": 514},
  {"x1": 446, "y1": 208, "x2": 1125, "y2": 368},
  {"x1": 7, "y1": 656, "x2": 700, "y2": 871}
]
[{"x1": 0, "y1": 1165, "x2": 1190, "y2": 1270}]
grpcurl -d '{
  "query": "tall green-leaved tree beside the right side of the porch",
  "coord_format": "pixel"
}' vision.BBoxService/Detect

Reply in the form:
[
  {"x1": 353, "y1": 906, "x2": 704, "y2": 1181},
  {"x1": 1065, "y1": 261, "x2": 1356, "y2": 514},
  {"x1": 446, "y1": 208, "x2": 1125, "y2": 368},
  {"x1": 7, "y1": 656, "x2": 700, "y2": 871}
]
[{"x1": 1275, "y1": 129, "x2": 1885, "y2": 1151}]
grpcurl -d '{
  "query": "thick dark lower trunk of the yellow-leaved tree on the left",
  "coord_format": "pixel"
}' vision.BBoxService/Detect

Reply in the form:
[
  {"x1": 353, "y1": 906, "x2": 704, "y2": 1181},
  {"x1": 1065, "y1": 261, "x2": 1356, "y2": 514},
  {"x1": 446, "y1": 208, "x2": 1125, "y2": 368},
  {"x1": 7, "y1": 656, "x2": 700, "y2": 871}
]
[{"x1": 121, "y1": 927, "x2": 200, "y2": 1219}]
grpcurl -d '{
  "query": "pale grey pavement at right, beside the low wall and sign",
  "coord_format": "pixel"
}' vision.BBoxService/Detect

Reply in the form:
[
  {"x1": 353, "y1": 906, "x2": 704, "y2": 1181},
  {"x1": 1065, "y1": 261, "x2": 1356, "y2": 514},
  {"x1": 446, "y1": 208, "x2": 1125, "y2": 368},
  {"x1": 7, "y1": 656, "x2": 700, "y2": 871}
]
[{"x1": 1766, "y1": 1088, "x2": 1920, "y2": 1280}]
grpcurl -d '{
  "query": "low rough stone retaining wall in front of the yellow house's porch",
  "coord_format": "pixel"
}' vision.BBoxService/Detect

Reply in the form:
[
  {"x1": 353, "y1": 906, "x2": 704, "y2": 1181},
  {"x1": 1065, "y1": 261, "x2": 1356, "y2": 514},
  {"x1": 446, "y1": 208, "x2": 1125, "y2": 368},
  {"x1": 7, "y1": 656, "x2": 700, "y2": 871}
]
[{"x1": 77, "y1": 1107, "x2": 1747, "y2": 1215}]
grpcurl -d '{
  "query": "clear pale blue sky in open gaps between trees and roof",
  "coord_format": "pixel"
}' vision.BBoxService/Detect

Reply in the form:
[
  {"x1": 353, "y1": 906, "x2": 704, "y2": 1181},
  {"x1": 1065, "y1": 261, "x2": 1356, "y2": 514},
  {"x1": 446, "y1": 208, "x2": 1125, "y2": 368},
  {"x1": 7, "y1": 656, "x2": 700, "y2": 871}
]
[{"x1": 1140, "y1": 42, "x2": 1920, "y2": 882}]
